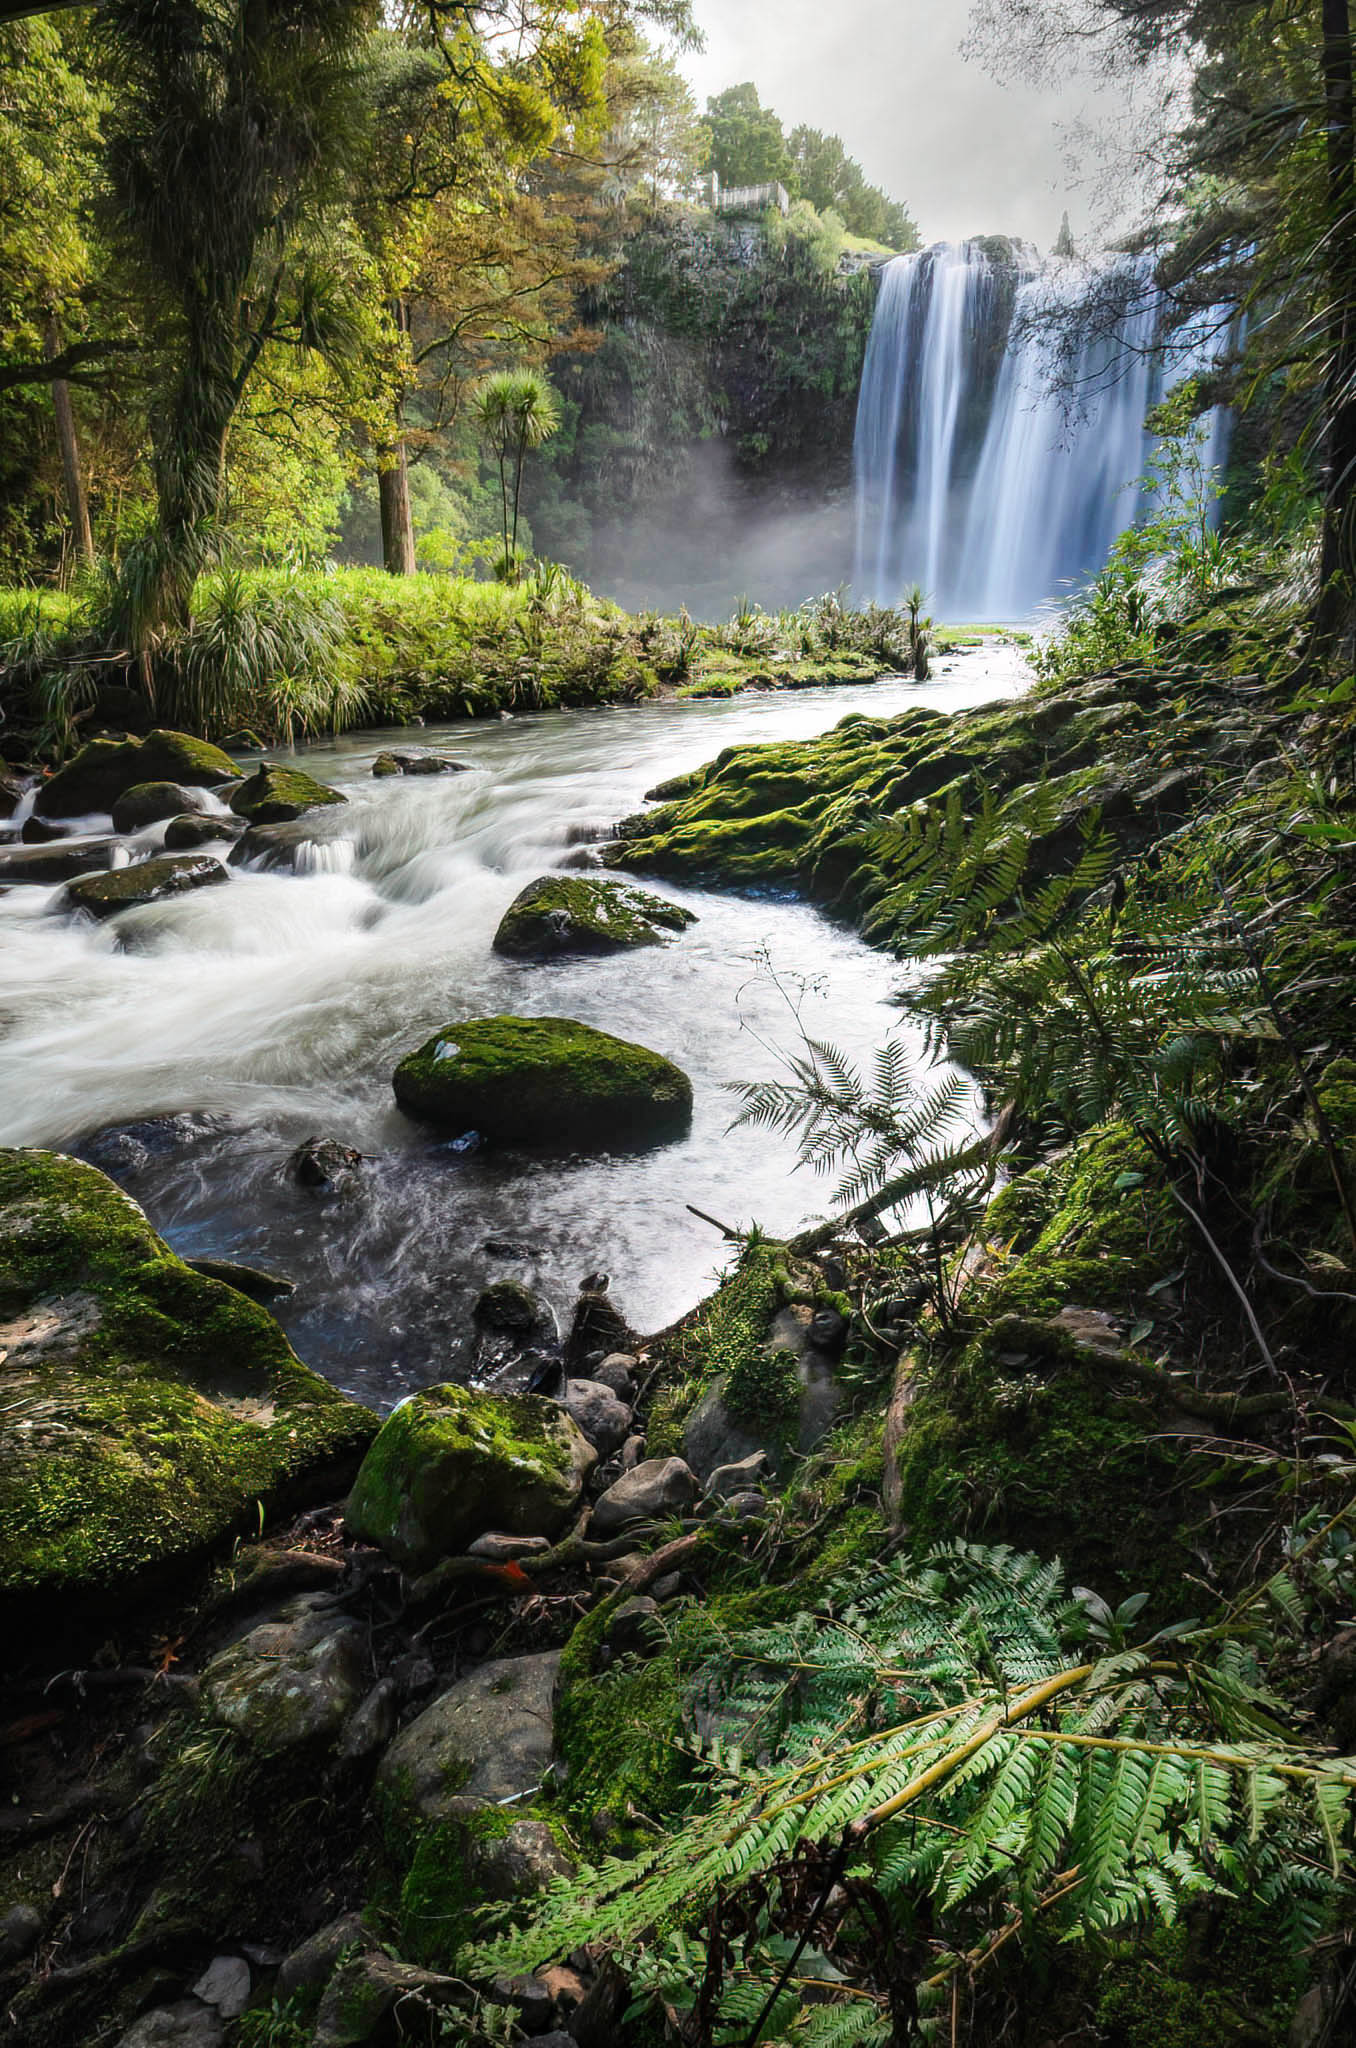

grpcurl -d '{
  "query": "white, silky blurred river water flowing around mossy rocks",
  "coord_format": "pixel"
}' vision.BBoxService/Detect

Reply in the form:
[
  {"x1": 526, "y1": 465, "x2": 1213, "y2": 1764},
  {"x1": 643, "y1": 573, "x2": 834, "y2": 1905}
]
[{"x1": 0, "y1": 645, "x2": 1022, "y2": 1407}]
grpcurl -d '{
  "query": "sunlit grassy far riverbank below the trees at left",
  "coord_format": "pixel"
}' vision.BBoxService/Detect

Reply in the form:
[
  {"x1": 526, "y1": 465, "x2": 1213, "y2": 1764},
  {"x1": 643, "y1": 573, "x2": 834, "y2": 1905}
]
[{"x1": 0, "y1": 565, "x2": 975, "y2": 762}]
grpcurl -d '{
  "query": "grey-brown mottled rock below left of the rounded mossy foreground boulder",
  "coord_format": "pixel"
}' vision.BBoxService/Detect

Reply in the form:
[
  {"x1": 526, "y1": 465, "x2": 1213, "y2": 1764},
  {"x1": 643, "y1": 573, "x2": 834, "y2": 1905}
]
[{"x1": 203, "y1": 1593, "x2": 367, "y2": 1755}]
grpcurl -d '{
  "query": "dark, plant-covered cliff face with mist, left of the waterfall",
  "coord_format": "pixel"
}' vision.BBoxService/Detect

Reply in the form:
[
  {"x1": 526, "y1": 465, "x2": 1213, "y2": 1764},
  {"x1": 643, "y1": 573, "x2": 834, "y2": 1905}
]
[{"x1": 524, "y1": 207, "x2": 877, "y2": 614}]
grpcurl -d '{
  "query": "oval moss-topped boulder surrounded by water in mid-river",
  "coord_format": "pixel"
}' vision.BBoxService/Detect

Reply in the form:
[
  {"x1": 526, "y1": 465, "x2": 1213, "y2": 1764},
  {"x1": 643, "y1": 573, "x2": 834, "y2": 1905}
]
[{"x1": 393, "y1": 1016, "x2": 692, "y2": 1149}]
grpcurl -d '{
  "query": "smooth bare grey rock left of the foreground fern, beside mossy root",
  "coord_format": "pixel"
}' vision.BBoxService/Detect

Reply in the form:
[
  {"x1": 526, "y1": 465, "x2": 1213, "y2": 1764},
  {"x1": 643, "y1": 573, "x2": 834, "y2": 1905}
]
[{"x1": 377, "y1": 1651, "x2": 561, "y2": 1821}]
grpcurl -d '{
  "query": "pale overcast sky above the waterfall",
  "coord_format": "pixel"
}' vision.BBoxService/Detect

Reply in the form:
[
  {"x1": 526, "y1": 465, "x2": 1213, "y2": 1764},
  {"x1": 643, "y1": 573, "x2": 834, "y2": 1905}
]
[{"x1": 684, "y1": 0, "x2": 1130, "y2": 248}]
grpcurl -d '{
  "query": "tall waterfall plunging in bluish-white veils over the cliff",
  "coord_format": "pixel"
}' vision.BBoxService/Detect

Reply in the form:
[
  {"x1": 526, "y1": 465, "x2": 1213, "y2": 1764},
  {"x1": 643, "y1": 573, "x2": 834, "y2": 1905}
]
[{"x1": 854, "y1": 242, "x2": 1227, "y2": 621}]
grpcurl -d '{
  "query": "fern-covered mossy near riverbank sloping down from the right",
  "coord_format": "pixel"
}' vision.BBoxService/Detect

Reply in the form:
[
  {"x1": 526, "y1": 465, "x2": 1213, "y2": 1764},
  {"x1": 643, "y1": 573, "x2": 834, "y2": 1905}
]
[{"x1": 6, "y1": 589, "x2": 1356, "y2": 2048}]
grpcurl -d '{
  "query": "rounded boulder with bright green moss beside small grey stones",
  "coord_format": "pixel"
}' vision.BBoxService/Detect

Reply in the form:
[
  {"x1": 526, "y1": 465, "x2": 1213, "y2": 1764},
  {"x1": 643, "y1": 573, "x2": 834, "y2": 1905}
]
[{"x1": 346, "y1": 1386, "x2": 596, "y2": 1571}]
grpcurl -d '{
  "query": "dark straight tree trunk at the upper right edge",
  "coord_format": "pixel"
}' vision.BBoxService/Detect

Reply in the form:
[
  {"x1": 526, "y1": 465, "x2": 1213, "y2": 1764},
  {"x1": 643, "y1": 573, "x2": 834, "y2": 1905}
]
[{"x1": 1315, "y1": 0, "x2": 1356, "y2": 641}]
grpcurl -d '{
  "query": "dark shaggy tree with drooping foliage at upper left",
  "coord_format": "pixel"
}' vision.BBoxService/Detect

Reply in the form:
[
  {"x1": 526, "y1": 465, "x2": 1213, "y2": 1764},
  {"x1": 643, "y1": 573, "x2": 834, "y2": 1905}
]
[{"x1": 98, "y1": 0, "x2": 375, "y2": 634}]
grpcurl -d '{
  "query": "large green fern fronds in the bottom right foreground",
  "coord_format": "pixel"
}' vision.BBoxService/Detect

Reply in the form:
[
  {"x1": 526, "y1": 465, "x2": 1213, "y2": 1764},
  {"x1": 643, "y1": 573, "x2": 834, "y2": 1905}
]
[{"x1": 473, "y1": 1542, "x2": 1356, "y2": 2048}]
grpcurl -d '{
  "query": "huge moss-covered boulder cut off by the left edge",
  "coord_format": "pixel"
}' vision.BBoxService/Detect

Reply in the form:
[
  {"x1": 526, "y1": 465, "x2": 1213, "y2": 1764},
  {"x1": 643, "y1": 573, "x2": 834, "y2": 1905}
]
[{"x1": 0, "y1": 1151, "x2": 377, "y2": 1610}]
